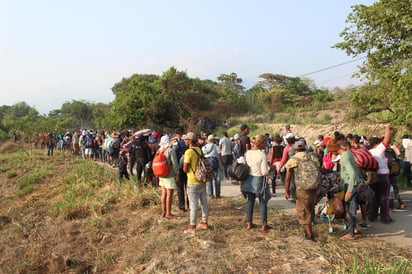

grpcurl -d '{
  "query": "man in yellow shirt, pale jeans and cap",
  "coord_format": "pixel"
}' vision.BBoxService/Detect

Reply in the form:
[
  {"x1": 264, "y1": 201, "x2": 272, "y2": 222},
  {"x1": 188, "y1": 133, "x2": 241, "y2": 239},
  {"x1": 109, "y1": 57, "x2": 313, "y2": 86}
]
[{"x1": 183, "y1": 132, "x2": 209, "y2": 233}]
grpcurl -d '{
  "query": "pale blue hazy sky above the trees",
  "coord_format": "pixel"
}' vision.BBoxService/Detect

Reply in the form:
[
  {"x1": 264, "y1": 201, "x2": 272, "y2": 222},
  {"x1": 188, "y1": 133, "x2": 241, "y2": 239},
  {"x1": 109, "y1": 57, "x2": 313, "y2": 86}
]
[{"x1": 0, "y1": 0, "x2": 375, "y2": 114}]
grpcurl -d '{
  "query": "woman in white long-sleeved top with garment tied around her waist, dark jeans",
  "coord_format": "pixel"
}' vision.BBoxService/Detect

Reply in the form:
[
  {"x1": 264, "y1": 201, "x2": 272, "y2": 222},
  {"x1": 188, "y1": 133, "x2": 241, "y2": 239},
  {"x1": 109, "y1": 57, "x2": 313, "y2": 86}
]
[{"x1": 242, "y1": 135, "x2": 271, "y2": 232}]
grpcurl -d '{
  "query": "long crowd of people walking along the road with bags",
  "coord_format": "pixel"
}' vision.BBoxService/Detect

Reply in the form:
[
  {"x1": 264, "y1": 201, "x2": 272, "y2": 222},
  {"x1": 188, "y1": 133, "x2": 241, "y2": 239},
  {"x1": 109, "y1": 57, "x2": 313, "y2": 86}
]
[{"x1": 27, "y1": 124, "x2": 412, "y2": 240}]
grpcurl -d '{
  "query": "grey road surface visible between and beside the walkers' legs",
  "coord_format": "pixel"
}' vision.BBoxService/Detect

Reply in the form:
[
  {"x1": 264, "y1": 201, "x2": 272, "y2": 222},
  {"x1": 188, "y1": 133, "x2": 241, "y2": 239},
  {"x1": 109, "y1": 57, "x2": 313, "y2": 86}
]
[{"x1": 221, "y1": 181, "x2": 412, "y2": 249}]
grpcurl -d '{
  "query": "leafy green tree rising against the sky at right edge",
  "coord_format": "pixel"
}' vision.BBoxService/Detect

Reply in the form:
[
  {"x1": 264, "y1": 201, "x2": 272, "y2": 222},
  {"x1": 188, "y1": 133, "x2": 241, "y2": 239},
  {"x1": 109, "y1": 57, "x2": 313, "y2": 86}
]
[{"x1": 334, "y1": 0, "x2": 412, "y2": 124}]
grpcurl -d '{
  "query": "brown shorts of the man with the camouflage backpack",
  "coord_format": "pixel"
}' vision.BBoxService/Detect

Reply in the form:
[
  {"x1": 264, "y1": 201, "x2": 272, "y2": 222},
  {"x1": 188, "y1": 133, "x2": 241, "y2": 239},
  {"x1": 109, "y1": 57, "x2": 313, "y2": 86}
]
[{"x1": 296, "y1": 190, "x2": 316, "y2": 225}]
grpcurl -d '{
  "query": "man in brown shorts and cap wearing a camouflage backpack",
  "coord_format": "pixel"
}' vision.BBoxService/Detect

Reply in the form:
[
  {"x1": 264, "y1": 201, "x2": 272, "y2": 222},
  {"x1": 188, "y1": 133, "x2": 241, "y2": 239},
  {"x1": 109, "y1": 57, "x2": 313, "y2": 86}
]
[{"x1": 285, "y1": 141, "x2": 320, "y2": 241}]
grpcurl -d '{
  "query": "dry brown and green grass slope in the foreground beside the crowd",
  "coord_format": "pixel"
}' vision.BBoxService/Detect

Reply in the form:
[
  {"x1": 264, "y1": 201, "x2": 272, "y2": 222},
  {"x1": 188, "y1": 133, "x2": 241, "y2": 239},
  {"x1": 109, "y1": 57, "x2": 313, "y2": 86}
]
[{"x1": 0, "y1": 144, "x2": 412, "y2": 273}]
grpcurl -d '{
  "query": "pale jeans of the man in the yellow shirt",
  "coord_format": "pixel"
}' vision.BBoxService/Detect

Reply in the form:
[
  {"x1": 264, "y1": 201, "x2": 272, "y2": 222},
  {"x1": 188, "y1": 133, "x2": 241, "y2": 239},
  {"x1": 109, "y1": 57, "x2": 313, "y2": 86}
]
[{"x1": 187, "y1": 184, "x2": 209, "y2": 226}]
